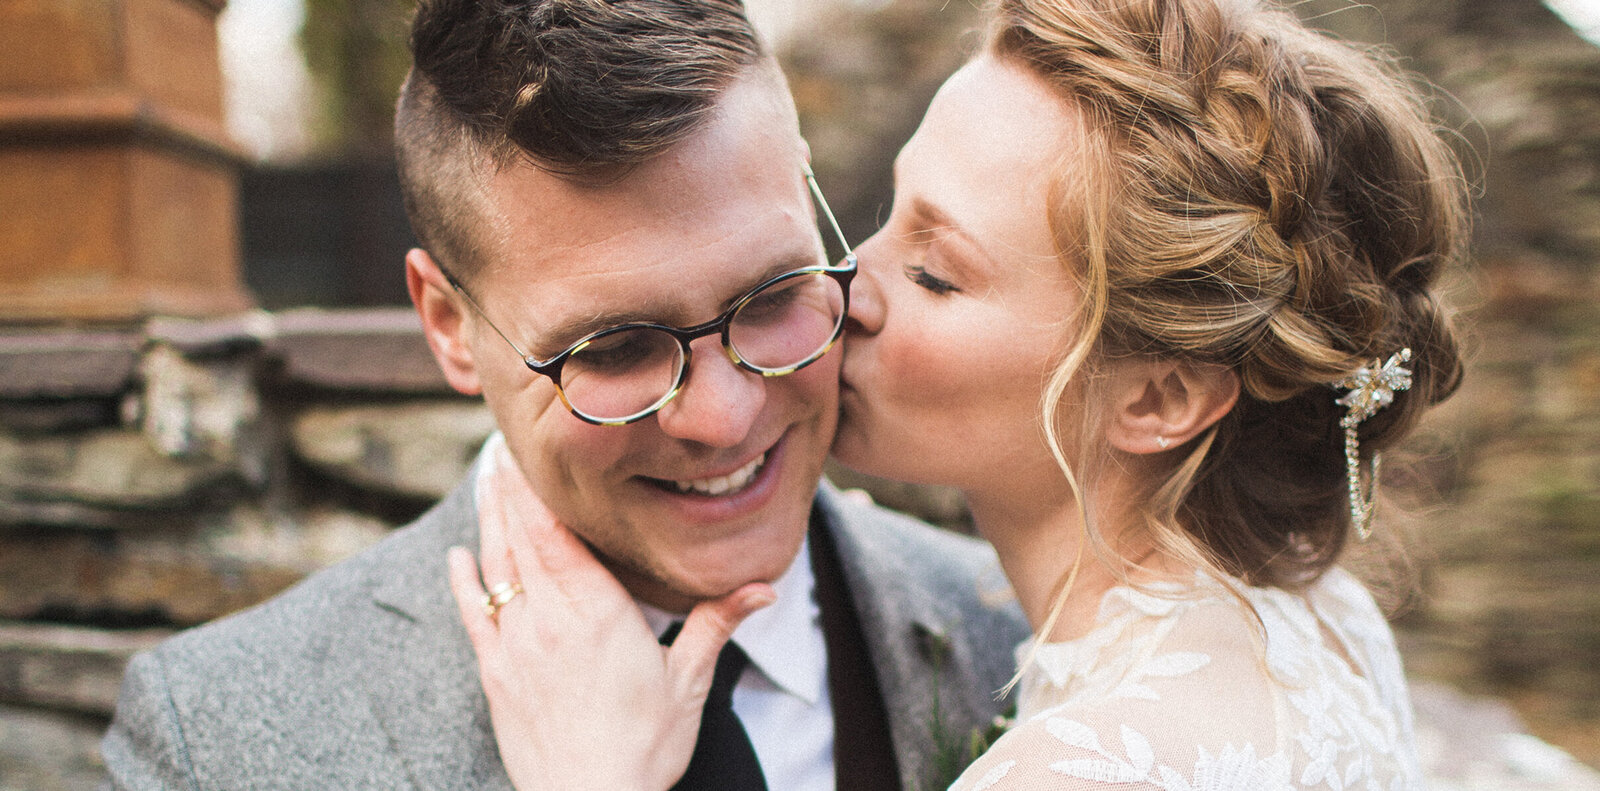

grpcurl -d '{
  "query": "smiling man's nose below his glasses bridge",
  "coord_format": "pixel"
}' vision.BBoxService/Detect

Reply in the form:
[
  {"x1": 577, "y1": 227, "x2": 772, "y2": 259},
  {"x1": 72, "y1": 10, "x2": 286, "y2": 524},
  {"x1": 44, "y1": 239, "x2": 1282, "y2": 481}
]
[{"x1": 656, "y1": 336, "x2": 766, "y2": 448}]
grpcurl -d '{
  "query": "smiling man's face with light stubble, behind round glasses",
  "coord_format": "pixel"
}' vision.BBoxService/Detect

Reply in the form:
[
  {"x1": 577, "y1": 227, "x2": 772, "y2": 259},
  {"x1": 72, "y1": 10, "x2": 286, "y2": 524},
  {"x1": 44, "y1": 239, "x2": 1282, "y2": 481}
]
[{"x1": 413, "y1": 67, "x2": 838, "y2": 610}]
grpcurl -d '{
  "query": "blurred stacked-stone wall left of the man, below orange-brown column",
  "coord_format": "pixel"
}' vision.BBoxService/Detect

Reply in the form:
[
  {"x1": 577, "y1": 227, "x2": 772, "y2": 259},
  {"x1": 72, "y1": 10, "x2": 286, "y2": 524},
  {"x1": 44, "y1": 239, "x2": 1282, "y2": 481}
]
[{"x1": 0, "y1": 309, "x2": 491, "y2": 791}]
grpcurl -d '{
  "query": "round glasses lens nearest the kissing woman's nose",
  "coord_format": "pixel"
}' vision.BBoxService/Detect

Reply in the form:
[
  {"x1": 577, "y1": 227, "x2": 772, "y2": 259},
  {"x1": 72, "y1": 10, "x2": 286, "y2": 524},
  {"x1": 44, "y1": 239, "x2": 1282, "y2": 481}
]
[{"x1": 728, "y1": 272, "x2": 845, "y2": 373}]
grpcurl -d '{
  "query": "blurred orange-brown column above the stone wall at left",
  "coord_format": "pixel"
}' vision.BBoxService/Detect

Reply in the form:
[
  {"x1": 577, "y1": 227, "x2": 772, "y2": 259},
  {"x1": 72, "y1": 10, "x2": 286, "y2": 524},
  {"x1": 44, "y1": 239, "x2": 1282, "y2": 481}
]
[{"x1": 0, "y1": 0, "x2": 251, "y2": 322}]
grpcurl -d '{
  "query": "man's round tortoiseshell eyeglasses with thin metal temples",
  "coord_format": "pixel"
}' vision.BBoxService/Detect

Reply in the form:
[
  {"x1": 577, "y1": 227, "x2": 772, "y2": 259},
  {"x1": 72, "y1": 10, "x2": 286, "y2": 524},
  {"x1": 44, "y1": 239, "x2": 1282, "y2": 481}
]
[{"x1": 440, "y1": 165, "x2": 856, "y2": 426}]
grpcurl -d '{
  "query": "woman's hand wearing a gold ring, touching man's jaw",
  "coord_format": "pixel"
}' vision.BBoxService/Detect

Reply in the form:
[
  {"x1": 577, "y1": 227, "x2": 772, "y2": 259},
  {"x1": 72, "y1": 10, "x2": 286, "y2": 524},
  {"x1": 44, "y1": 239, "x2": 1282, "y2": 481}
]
[{"x1": 450, "y1": 442, "x2": 774, "y2": 791}]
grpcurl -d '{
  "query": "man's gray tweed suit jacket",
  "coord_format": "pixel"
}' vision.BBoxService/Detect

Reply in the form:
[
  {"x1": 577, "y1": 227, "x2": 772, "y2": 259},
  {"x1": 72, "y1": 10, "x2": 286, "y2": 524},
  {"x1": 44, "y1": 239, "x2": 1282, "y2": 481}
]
[{"x1": 102, "y1": 476, "x2": 1024, "y2": 791}]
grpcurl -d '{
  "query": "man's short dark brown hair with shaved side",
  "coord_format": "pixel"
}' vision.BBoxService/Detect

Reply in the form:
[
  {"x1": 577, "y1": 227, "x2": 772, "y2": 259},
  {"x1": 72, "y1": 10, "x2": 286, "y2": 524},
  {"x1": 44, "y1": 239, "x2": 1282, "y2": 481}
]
[{"x1": 395, "y1": 0, "x2": 763, "y2": 277}]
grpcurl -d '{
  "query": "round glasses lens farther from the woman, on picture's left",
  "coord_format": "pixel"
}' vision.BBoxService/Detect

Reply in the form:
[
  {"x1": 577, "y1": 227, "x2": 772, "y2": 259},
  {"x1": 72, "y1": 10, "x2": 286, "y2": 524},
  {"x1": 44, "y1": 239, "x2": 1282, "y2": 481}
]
[{"x1": 562, "y1": 327, "x2": 683, "y2": 421}]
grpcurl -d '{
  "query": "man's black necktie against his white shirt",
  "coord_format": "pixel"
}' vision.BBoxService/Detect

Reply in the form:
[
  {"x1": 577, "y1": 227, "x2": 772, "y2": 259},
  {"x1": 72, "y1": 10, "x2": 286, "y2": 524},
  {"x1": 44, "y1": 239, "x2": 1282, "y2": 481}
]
[{"x1": 661, "y1": 623, "x2": 766, "y2": 791}]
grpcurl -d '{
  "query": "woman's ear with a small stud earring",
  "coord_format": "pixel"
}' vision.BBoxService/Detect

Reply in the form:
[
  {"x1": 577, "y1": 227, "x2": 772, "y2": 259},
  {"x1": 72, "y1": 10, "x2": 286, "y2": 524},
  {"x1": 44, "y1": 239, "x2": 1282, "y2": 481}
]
[{"x1": 1106, "y1": 360, "x2": 1238, "y2": 453}]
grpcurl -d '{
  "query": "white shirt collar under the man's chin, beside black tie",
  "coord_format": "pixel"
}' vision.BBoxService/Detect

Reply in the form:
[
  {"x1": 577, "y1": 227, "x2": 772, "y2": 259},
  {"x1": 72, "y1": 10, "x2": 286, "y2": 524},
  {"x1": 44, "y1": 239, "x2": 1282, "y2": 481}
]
[{"x1": 638, "y1": 540, "x2": 827, "y2": 705}]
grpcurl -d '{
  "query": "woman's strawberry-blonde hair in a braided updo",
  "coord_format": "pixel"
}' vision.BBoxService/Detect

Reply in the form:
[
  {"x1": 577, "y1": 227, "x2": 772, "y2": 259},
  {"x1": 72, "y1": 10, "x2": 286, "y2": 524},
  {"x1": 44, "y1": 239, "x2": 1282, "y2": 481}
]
[{"x1": 989, "y1": 0, "x2": 1467, "y2": 588}]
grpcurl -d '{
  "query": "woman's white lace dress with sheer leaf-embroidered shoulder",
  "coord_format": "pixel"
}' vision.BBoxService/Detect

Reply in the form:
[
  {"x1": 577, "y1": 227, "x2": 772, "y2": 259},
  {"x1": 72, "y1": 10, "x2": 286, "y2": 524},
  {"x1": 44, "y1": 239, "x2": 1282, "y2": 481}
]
[{"x1": 950, "y1": 570, "x2": 1422, "y2": 791}]
